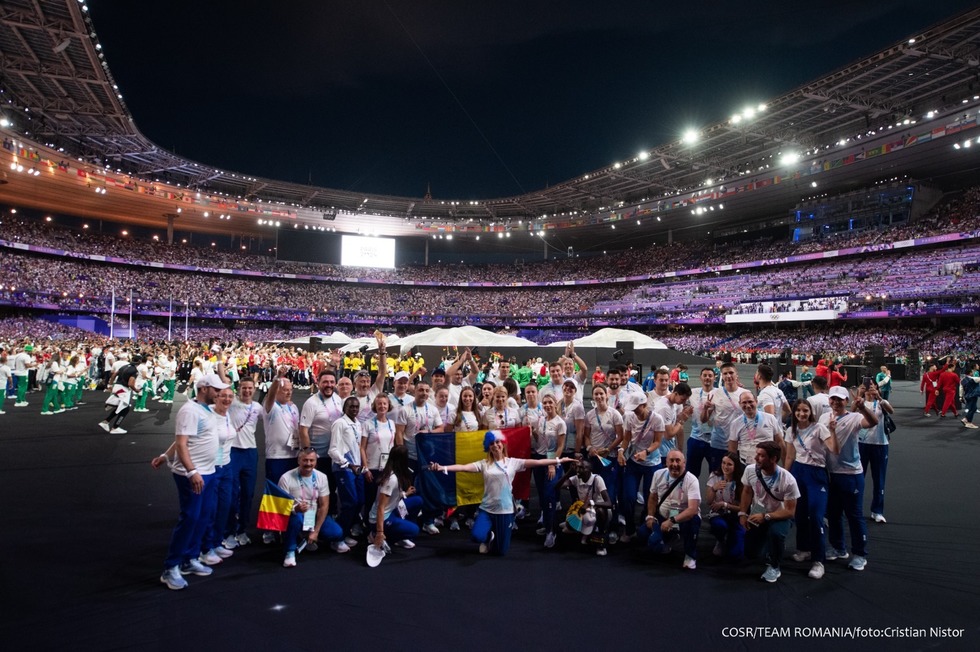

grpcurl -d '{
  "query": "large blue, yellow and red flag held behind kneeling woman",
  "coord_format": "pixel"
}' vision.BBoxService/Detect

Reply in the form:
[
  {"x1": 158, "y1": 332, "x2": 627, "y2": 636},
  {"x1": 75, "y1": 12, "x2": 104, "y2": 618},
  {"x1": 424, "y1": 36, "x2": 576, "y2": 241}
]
[{"x1": 418, "y1": 426, "x2": 531, "y2": 510}]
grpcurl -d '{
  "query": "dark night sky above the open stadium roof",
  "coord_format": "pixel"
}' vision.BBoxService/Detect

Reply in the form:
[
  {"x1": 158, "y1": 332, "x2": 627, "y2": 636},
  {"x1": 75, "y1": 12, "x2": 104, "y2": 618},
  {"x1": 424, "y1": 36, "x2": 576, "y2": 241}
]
[{"x1": 88, "y1": 0, "x2": 975, "y2": 200}]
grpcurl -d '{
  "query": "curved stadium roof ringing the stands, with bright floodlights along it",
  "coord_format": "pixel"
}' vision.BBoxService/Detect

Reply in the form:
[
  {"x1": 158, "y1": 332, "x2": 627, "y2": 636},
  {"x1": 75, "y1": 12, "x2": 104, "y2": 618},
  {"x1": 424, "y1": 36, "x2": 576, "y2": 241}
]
[{"x1": 0, "y1": 0, "x2": 980, "y2": 232}]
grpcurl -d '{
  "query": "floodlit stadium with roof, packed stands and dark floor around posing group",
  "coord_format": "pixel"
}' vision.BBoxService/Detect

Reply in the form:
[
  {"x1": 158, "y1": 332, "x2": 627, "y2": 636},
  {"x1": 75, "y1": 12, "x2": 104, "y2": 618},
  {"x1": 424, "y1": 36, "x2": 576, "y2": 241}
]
[{"x1": 0, "y1": 0, "x2": 980, "y2": 649}]
